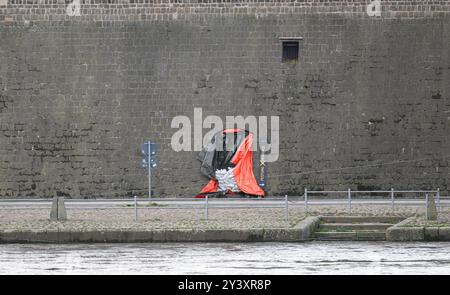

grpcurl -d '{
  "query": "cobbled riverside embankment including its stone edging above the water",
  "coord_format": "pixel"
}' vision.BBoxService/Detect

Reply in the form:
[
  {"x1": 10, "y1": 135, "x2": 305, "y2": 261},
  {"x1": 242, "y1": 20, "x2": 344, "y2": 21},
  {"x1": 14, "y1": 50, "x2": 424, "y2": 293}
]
[{"x1": 0, "y1": 206, "x2": 450, "y2": 243}]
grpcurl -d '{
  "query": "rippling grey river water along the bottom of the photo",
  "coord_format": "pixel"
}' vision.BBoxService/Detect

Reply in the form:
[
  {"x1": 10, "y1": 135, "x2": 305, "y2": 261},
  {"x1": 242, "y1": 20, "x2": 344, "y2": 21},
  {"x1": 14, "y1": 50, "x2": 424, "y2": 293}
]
[{"x1": 0, "y1": 242, "x2": 450, "y2": 275}]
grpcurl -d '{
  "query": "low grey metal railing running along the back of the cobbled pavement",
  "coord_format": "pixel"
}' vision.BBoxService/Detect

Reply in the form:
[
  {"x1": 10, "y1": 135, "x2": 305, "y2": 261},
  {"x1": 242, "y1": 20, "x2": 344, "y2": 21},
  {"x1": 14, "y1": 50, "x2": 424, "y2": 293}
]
[{"x1": 0, "y1": 188, "x2": 442, "y2": 221}]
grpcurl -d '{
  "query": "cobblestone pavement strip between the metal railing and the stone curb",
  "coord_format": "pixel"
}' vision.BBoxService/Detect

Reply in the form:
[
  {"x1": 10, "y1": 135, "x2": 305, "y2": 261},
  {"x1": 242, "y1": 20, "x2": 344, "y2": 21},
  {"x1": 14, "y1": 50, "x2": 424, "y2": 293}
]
[{"x1": 0, "y1": 205, "x2": 442, "y2": 231}]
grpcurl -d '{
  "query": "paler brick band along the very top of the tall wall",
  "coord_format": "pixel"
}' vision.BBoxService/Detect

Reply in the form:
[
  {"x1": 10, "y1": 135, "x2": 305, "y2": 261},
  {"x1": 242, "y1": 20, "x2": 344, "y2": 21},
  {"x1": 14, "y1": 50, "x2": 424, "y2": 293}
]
[{"x1": 0, "y1": 0, "x2": 450, "y2": 22}]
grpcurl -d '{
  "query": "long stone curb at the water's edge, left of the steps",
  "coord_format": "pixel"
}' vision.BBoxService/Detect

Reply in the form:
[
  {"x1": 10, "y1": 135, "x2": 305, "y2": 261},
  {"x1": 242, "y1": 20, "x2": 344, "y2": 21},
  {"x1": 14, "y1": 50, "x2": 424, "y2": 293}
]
[{"x1": 0, "y1": 217, "x2": 320, "y2": 243}]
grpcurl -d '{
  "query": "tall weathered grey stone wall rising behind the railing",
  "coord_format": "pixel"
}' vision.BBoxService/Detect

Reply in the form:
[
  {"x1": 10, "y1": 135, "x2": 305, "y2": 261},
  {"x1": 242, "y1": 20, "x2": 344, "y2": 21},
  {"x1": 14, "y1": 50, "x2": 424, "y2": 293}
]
[{"x1": 0, "y1": 0, "x2": 450, "y2": 197}]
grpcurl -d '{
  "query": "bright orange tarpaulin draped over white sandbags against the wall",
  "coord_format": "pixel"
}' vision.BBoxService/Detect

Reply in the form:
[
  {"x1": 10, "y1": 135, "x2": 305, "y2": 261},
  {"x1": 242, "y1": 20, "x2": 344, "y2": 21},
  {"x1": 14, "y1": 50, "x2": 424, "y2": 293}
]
[{"x1": 201, "y1": 129, "x2": 264, "y2": 196}]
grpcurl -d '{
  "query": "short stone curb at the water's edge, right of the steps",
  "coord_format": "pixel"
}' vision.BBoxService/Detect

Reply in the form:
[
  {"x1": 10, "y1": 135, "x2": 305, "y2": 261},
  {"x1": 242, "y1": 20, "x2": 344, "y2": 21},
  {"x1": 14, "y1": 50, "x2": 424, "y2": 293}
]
[{"x1": 386, "y1": 217, "x2": 450, "y2": 242}]
